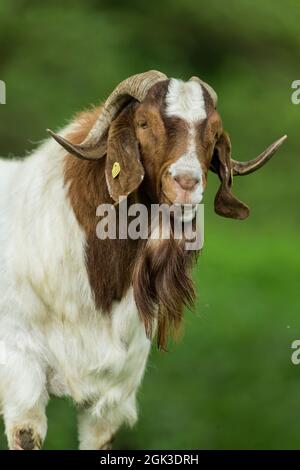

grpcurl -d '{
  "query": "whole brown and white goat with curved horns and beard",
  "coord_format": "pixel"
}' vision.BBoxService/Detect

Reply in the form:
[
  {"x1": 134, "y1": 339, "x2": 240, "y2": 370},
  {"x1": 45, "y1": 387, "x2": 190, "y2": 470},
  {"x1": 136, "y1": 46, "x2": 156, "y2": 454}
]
[{"x1": 0, "y1": 71, "x2": 285, "y2": 450}]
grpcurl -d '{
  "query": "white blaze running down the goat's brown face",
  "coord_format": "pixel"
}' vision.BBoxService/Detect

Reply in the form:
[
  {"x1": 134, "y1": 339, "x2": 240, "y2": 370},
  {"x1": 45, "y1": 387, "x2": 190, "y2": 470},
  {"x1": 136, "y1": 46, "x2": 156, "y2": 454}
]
[{"x1": 166, "y1": 78, "x2": 207, "y2": 204}]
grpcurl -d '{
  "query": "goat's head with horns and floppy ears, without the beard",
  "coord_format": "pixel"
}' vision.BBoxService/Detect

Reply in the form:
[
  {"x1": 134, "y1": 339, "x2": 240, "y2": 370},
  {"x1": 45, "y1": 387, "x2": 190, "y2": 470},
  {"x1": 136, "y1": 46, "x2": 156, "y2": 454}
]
[{"x1": 50, "y1": 71, "x2": 286, "y2": 219}]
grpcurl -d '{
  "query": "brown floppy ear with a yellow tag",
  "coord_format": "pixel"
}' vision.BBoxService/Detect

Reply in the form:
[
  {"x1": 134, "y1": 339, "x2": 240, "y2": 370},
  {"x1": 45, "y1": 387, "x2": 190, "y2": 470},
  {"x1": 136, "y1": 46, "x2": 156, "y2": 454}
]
[{"x1": 105, "y1": 106, "x2": 145, "y2": 202}]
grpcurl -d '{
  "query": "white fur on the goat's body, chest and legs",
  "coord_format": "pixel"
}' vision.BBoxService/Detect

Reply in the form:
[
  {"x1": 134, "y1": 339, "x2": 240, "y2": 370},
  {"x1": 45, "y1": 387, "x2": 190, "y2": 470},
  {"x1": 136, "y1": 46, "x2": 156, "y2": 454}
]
[{"x1": 0, "y1": 125, "x2": 150, "y2": 449}]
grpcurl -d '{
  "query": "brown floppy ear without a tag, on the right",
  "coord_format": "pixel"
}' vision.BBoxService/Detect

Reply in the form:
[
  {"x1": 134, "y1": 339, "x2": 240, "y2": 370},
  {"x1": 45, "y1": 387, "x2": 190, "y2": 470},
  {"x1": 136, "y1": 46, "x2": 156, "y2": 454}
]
[{"x1": 211, "y1": 132, "x2": 249, "y2": 219}]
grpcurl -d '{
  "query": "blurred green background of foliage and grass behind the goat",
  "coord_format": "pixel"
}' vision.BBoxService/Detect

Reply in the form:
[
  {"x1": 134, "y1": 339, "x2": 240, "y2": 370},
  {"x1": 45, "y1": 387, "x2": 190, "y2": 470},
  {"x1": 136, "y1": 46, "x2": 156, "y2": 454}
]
[{"x1": 0, "y1": 0, "x2": 300, "y2": 449}]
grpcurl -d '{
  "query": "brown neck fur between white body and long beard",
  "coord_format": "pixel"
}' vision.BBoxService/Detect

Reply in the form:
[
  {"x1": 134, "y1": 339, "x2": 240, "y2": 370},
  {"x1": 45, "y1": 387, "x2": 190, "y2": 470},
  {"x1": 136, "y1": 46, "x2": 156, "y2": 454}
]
[{"x1": 65, "y1": 110, "x2": 138, "y2": 312}]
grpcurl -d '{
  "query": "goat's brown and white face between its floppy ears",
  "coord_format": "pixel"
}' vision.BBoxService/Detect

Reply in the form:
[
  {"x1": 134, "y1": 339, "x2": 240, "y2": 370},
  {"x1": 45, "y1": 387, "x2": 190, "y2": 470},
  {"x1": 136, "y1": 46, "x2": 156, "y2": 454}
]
[{"x1": 133, "y1": 79, "x2": 222, "y2": 209}]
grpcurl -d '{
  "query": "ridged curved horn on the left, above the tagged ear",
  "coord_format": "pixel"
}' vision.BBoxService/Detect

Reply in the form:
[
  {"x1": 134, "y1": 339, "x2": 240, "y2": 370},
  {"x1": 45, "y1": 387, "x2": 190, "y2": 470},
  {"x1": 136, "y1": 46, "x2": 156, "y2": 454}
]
[{"x1": 48, "y1": 70, "x2": 168, "y2": 160}]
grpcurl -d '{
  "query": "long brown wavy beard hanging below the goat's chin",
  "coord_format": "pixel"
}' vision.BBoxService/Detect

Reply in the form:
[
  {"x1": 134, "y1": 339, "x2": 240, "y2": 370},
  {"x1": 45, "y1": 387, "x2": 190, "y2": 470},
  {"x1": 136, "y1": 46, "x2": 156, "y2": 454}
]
[{"x1": 133, "y1": 226, "x2": 197, "y2": 350}]
